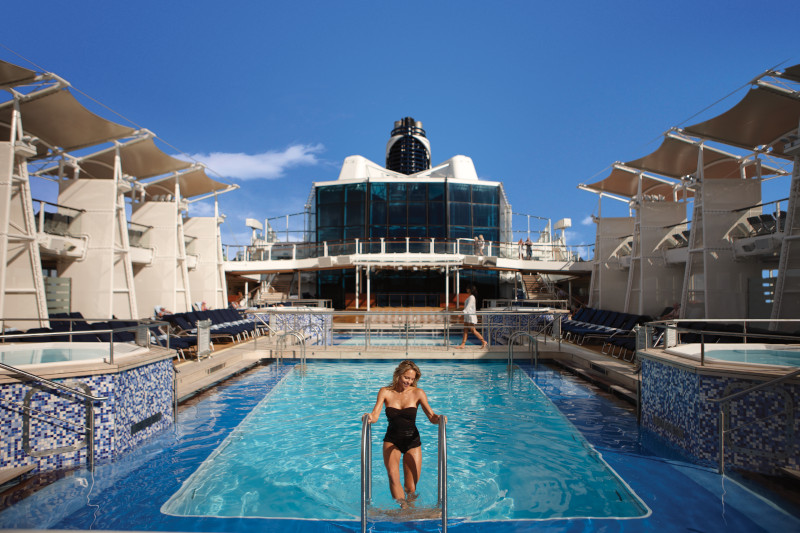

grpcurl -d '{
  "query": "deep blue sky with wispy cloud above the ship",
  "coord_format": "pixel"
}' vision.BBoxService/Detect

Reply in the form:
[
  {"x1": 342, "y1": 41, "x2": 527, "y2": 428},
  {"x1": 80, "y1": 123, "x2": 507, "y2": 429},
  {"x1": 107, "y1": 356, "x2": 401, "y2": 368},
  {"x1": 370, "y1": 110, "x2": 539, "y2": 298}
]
[{"x1": 0, "y1": 0, "x2": 800, "y2": 249}]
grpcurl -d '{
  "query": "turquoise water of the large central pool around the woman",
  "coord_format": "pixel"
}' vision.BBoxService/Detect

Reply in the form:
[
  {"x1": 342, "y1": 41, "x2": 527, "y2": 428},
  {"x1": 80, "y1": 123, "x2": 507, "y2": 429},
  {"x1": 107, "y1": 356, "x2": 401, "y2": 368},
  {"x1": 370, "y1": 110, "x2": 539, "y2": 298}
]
[{"x1": 162, "y1": 362, "x2": 649, "y2": 520}]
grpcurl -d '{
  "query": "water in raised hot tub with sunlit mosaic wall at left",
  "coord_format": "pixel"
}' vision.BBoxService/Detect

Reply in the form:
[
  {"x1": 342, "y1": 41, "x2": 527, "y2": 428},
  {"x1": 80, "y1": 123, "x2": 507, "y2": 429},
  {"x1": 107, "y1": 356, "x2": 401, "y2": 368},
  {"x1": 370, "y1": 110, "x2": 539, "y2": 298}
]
[{"x1": 0, "y1": 342, "x2": 147, "y2": 366}]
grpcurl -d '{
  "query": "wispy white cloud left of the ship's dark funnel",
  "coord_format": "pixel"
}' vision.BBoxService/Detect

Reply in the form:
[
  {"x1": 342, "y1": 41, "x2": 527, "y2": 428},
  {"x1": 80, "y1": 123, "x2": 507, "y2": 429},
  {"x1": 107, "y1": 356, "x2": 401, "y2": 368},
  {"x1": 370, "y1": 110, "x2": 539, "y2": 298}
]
[{"x1": 184, "y1": 144, "x2": 324, "y2": 180}]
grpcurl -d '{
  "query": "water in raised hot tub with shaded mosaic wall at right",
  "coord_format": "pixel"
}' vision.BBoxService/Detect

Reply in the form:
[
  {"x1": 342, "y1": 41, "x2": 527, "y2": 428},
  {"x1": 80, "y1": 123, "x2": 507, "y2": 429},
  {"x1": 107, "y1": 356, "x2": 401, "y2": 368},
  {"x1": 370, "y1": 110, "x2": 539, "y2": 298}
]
[{"x1": 665, "y1": 343, "x2": 800, "y2": 367}]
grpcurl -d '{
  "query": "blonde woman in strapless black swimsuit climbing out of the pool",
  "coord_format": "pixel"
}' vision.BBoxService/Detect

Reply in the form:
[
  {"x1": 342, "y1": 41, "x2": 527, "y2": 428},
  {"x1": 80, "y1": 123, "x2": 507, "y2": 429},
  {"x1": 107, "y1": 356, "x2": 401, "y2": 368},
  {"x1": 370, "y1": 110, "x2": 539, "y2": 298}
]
[{"x1": 369, "y1": 361, "x2": 439, "y2": 501}]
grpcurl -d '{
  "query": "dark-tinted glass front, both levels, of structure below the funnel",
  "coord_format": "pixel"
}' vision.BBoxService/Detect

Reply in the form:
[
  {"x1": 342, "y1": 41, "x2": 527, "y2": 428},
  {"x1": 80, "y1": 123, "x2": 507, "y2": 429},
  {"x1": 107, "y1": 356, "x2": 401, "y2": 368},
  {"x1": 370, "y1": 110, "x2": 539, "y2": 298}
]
[{"x1": 309, "y1": 178, "x2": 508, "y2": 308}]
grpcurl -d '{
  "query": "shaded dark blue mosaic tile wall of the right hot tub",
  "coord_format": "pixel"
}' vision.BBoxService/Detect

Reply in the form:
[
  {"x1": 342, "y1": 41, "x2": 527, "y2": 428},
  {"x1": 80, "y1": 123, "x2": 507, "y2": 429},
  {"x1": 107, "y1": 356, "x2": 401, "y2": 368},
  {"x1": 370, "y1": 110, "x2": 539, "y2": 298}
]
[{"x1": 642, "y1": 359, "x2": 800, "y2": 474}]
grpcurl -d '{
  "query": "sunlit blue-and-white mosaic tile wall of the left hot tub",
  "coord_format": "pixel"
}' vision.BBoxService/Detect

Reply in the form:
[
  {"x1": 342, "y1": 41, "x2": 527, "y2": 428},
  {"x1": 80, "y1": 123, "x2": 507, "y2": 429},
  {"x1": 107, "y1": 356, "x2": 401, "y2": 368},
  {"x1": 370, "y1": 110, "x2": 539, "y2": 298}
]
[{"x1": 0, "y1": 359, "x2": 173, "y2": 471}]
